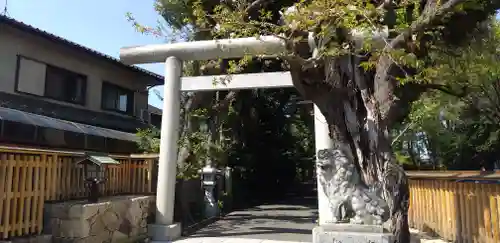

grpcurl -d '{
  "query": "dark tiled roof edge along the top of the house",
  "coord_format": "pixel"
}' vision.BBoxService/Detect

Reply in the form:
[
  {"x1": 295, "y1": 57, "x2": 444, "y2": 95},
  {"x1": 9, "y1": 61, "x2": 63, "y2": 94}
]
[{"x1": 0, "y1": 14, "x2": 164, "y2": 84}]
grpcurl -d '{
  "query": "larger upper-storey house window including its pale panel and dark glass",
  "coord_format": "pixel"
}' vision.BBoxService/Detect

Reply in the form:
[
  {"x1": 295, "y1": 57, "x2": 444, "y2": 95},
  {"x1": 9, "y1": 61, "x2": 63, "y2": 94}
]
[{"x1": 16, "y1": 56, "x2": 87, "y2": 105}]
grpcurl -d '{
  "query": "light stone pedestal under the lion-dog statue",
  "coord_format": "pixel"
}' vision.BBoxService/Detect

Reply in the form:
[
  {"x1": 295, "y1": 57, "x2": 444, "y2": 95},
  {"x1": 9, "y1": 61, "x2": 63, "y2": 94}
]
[{"x1": 313, "y1": 224, "x2": 394, "y2": 243}]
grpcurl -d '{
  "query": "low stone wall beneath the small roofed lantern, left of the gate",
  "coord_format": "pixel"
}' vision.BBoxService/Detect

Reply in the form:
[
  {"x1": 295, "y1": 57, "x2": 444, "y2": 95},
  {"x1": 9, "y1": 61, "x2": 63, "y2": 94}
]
[{"x1": 44, "y1": 196, "x2": 155, "y2": 243}]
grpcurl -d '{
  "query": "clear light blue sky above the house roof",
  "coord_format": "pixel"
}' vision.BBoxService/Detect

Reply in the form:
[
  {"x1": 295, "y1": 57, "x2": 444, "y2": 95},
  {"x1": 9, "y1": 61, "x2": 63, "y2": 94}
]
[{"x1": 0, "y1": 0, "x2": 164, "y2": 108}]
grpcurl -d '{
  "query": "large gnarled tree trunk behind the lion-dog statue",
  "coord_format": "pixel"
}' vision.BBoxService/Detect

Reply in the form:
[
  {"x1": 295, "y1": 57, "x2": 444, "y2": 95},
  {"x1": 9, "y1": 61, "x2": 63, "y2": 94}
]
[{"x1": 292, "y1": 56, "x2": 410, "y2": 243}]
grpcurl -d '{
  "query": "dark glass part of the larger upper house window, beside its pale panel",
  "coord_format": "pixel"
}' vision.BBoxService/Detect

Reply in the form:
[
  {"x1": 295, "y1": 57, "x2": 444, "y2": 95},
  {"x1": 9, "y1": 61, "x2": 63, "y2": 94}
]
[{"x1": 45, "y1": 66, "x2": 87, "y2": 105}]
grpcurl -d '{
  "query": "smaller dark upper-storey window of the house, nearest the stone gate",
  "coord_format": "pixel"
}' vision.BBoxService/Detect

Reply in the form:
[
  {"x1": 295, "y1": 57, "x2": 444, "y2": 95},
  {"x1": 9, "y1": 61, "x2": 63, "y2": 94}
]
[{"x1": 102, "y1": 82, "x2": 134, "y2": 115}]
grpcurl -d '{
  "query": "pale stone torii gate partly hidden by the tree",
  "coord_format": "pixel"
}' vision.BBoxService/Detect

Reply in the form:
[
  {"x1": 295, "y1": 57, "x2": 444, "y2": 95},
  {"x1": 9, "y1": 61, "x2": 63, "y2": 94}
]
[{"x1": 120, "y1": 36, "x2": 333, "y2": 242}]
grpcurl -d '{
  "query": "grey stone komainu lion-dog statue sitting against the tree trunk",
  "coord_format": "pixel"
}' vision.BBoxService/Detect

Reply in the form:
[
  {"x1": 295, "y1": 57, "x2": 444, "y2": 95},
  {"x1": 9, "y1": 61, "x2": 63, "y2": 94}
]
[{"x1": 316, "y1": 149, "x2": 389, "y2": 225}]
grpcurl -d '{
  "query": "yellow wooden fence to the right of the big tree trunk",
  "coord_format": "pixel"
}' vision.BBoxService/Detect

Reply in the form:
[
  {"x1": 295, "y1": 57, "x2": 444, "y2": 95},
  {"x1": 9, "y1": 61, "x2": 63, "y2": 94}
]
[{"x1": 408, "y1": 171, "x2": 500, "y2": 243}]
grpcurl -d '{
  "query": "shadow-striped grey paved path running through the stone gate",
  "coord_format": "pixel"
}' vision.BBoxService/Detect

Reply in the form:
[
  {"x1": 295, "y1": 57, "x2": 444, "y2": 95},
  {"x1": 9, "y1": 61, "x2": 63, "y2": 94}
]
[{"x1": 178, "y1": 199, "x2": 317, "y2": 243}]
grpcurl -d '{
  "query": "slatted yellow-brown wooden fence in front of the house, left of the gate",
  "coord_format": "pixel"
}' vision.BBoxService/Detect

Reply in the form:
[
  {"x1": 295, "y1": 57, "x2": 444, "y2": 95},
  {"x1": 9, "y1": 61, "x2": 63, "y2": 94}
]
[{"x1": 0, "y1": 146, "x2": 157, "y2": 239}]
